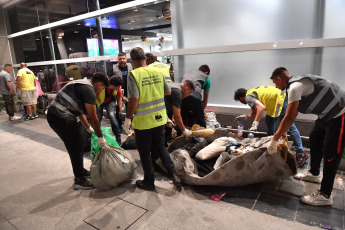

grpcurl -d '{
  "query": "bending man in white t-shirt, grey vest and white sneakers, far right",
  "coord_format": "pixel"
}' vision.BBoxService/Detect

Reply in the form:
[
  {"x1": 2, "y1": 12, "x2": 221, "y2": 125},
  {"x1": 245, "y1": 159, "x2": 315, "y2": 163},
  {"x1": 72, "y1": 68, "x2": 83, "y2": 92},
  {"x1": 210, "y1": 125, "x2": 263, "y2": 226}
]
[{"x1": 267, "y1": 67, "x2": 345, "y2": 205}]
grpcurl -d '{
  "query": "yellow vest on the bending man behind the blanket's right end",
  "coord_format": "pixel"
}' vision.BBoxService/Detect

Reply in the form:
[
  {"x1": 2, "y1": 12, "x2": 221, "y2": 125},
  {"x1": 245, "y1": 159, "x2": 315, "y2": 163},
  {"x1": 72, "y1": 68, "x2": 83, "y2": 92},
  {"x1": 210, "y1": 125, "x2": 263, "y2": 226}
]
[{"x1": 246, "y1": 86, "x2": 286, "y2": 117}]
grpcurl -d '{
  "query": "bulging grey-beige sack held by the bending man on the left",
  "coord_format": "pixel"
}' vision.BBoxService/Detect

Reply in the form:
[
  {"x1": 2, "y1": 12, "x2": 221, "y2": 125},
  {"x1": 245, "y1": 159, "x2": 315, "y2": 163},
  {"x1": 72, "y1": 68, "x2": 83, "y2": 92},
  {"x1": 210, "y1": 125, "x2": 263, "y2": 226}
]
[{"x1": 90, "y1": 145, "x2": 137, "y2": 190}]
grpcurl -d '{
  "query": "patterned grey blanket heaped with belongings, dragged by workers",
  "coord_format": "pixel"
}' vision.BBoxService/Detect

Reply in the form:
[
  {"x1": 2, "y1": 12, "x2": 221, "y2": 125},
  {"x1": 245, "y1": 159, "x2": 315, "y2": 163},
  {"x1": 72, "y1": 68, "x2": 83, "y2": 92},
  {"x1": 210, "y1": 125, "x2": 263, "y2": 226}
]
[{"x1": 162, "y1": 129, "x2": 297, "y2": 186}]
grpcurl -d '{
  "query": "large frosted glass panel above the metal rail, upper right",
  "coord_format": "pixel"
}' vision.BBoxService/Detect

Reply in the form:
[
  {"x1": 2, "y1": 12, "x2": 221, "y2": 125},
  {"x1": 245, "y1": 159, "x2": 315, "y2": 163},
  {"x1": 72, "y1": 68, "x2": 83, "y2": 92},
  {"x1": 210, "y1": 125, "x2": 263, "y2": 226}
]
[{"x1": 171, "y1": 0, "x2": 317, "y2": 49}]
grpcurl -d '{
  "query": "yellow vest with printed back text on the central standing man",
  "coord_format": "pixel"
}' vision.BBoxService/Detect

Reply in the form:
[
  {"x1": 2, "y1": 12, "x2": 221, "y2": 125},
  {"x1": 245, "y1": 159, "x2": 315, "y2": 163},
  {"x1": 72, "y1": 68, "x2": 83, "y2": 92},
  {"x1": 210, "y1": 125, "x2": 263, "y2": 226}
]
[{"x1": 131, "y1": 66, "x2": 167, "y2": 130}]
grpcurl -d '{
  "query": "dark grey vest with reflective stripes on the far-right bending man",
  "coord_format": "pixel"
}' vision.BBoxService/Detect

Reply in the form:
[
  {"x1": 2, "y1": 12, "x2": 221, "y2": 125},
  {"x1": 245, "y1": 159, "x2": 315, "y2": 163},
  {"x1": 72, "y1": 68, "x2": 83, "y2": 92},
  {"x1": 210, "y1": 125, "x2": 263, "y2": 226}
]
[{"x1": 288, "y1": 74, "x2": 345, "y2": 121}]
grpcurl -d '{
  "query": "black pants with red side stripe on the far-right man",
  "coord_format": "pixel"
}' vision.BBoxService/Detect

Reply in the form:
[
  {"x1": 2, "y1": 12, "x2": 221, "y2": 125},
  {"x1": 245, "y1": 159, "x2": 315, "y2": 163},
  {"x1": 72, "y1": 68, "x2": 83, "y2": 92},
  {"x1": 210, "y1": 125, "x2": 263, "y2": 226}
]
[{"x1": 309, "y1": 114, "x2": 345, "y2": 195}]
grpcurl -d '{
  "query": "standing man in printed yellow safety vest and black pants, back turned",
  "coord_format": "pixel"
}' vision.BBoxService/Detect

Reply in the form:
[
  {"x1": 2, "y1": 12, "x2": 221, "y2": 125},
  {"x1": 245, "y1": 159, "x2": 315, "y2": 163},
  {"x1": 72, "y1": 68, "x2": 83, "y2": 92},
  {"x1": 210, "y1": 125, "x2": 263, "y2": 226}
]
[{"x1": 124, "y1": 47, "x2": 181, "y2": 190}]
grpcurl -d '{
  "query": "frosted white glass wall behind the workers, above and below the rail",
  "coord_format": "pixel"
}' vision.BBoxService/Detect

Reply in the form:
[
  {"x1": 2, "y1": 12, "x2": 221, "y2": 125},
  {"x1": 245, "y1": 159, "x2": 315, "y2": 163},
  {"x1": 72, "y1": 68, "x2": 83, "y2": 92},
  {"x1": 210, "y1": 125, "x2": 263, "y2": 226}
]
[{"x1": 171, "y1": 0, "x2": 345, "y2": 107}]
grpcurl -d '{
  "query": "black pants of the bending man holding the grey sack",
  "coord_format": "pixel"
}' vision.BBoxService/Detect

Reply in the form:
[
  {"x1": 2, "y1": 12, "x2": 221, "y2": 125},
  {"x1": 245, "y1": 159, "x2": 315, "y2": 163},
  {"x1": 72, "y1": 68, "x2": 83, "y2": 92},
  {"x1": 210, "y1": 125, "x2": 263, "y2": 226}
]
[{"x1": 47, "y1": 110, "x2": 84, "y2": 178}]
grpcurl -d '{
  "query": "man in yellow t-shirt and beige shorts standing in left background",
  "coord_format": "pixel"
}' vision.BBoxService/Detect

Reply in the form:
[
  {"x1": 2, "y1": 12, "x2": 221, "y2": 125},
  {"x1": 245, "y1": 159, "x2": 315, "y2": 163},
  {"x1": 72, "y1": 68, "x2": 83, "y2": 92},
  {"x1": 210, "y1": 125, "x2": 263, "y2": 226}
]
[{"x1": 16, "y1": 62, "x2": 38, "y2": 120}]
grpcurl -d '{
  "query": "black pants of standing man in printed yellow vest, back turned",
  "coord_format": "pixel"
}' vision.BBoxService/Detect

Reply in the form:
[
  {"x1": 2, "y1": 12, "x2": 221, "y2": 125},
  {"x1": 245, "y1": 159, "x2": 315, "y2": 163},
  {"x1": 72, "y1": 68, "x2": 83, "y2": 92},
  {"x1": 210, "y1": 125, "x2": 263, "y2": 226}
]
[{"x1": 134, "y1": 125, "x2": 176, "y2": 184}]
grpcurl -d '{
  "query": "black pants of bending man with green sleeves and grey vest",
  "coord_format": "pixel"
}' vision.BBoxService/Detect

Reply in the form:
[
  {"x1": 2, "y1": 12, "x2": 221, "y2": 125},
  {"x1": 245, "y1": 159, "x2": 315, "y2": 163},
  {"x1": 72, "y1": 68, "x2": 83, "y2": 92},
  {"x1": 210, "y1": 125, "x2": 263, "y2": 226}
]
[{"x1": 181, "y1": 96, "x2": 206, "y2": 128}]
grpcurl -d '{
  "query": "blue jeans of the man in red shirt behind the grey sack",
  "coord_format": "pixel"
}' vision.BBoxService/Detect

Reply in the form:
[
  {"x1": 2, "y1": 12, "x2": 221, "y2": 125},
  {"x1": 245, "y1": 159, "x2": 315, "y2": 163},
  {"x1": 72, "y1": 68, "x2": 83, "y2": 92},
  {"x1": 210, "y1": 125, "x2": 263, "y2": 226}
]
[{"x1": 97, "y1": 101, "x2": 121, "y2": 145}]
